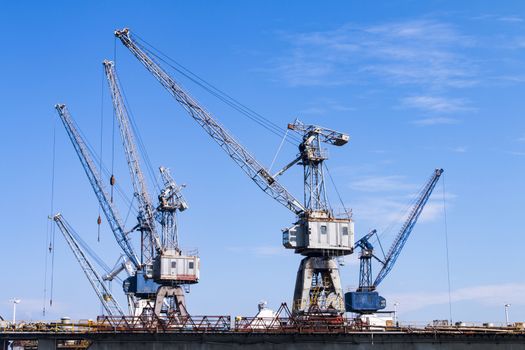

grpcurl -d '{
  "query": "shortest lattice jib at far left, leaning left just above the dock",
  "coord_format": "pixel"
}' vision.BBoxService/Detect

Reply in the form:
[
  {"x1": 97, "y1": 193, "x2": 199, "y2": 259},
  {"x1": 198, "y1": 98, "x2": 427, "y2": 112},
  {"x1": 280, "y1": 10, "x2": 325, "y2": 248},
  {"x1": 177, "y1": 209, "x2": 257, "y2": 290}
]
[{"x1": 53, "y1": 213, "x2": 124, "y2": 316}]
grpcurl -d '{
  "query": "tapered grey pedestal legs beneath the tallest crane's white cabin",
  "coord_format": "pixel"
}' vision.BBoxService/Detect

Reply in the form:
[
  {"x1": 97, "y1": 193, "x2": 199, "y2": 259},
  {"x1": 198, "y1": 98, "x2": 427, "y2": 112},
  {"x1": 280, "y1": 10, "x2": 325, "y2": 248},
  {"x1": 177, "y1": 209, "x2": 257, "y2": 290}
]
[{"x1": 292, "y1": 257, "x2": 345, "y2": 315}]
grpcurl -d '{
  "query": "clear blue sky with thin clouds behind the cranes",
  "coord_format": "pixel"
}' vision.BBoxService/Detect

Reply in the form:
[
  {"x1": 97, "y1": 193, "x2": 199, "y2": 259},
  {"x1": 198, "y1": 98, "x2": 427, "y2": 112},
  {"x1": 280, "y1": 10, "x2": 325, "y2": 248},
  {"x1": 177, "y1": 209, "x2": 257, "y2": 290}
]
[{"x1": 0, "y1": 1, "x2": 525, "y2": 323}]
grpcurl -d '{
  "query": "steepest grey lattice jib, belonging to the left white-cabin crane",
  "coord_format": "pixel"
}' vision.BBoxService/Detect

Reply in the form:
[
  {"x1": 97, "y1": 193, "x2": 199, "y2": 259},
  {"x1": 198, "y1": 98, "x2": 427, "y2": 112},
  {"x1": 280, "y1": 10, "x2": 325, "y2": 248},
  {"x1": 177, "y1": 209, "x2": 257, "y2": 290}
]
[{"x1": 103, "y1": 60, "x2": 161, "y2": 266}]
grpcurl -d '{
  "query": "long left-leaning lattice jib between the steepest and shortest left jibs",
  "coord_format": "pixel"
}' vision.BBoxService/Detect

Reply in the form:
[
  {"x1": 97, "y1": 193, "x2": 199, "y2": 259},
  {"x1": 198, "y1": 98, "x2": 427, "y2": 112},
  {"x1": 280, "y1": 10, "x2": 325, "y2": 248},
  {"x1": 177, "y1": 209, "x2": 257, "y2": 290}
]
[{"x1": 55, "y1": 104, "x2": 141, "y2": 269}]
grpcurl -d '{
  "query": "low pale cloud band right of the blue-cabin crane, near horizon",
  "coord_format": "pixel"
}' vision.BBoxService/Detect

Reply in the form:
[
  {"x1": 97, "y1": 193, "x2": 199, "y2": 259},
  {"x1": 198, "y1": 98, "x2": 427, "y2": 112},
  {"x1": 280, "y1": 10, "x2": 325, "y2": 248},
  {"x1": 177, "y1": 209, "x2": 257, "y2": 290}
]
[{"x1": 390, "y1": 283, "x2": 525, "y2": 311}]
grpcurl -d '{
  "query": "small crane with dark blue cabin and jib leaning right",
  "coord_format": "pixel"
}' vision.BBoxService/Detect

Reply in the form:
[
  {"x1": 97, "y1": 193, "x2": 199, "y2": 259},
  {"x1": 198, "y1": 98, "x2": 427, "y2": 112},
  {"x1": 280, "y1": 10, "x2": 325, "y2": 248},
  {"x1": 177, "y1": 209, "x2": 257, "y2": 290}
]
[{"x1": 345, "y1": 169, "x2": 443, "y2": 314}]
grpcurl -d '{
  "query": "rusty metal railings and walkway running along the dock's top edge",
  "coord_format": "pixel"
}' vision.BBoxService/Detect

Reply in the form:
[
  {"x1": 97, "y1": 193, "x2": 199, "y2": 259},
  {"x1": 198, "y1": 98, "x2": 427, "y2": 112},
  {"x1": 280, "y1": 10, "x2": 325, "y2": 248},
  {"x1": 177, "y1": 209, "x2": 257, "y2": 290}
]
[{"x1": 0, "y1": 303, "x2": 525, "y2": 334}]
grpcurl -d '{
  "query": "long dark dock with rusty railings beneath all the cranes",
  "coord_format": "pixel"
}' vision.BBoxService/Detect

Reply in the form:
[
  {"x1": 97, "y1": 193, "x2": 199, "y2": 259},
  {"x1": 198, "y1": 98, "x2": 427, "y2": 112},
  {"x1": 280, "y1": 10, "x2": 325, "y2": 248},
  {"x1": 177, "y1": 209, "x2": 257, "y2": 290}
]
[{"x1": 0, "y1": 316, "x2": 525, "y2": 350}]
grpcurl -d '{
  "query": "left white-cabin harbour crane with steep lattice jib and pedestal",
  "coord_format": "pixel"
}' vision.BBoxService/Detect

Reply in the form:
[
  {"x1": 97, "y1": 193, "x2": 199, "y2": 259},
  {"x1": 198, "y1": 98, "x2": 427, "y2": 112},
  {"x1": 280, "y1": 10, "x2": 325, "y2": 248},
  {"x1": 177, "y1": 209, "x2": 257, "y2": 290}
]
[{"x1": 102, "y1": 60, "x2": 199, "y2": 315}]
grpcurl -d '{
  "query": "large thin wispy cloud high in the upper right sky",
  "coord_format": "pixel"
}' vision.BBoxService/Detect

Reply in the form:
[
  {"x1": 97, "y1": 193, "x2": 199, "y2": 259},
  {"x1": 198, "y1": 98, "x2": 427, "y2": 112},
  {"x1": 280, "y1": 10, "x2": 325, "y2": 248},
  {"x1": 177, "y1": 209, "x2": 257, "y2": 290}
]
[{"x1": 276, "y1": 20, "x2": 477, "y2": 88}]
